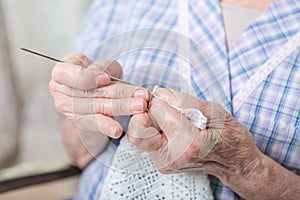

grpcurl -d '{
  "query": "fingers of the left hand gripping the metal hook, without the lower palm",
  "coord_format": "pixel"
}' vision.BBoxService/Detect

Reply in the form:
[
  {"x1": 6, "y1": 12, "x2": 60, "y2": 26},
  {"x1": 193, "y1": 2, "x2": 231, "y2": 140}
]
[{"x1": 49, "y1": 53, "x2": 149, "y2": 138}]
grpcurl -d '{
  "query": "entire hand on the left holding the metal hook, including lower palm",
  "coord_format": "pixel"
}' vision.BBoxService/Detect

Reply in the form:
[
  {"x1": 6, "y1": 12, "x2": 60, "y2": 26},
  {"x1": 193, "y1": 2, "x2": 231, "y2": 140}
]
[{"x1": 49, "y1": 53, "x2": 149, "y2": 168}]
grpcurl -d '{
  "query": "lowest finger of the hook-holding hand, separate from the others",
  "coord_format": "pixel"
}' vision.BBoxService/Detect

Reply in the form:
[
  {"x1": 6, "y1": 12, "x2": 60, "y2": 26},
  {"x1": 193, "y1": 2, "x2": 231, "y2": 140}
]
[{"x1": 71, "y1": 114, "x2": 123, "y2": 138}]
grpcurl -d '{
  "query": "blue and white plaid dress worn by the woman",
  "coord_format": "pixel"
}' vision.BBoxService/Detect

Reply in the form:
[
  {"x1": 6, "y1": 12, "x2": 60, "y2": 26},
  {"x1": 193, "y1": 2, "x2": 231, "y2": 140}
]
[{"x1": 72, "y1": 0, "x2": 300, "y2": 199}]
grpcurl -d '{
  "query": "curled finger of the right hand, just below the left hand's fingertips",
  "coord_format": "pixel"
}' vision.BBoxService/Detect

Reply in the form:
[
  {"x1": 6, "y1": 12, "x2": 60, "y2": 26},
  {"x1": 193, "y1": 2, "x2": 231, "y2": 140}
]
[{"x1": 127, "y1": 113, "x2": 167, "y2": 152}]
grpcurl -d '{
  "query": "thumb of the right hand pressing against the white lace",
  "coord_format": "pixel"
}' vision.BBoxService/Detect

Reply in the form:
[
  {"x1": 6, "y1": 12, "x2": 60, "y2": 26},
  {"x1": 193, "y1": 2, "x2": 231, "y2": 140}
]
[{"x1": 150, "y1": 98, "x2": 202, "y2": 167}]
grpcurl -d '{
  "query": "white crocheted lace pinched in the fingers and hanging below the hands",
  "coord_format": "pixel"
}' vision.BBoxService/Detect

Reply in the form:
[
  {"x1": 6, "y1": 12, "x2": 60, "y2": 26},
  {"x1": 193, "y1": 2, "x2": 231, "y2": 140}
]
[{"x1": 100, "y1": 87, "x2": 214, "y2": 200}]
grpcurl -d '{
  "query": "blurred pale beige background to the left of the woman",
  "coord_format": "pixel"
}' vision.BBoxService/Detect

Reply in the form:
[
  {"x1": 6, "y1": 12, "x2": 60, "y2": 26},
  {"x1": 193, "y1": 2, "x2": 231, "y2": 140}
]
[{"x1": 0, "y1": 0, "x2": 91, "y2": 199}]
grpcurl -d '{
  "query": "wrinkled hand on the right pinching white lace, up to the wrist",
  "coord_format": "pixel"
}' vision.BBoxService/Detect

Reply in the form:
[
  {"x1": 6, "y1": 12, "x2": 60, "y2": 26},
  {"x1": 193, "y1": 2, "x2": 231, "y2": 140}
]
[{"x1": 127, "y1": 89, "x2": 261, "y2": 174}]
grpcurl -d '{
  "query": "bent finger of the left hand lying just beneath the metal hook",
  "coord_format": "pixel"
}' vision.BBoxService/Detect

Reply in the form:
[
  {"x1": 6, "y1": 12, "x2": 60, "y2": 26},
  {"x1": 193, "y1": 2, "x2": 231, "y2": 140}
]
[{"x1": 52, "y1": 63, "x2": 110, "y2": 90}]
